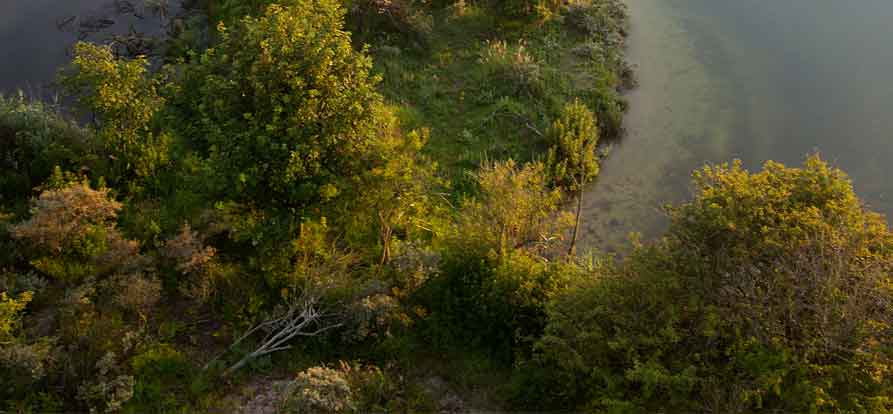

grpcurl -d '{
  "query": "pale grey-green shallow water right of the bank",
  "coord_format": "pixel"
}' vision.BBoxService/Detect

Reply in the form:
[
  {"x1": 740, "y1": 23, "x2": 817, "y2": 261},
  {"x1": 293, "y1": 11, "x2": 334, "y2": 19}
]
[{"x1": 584, "y1": 0, "x2": 893, "y2": 251}]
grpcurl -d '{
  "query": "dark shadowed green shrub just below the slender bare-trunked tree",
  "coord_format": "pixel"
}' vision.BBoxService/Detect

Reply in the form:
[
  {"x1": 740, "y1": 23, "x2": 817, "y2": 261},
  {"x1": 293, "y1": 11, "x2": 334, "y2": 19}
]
[{"x1": 419, "y1": 246, "x2": 580, "y2": 362}]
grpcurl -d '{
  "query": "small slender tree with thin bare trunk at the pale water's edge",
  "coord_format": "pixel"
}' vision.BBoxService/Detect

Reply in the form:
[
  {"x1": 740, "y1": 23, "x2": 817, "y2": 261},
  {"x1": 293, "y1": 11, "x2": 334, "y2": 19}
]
[{"x1": 547, "y1": 99, "x2": 599, "y2": 253}]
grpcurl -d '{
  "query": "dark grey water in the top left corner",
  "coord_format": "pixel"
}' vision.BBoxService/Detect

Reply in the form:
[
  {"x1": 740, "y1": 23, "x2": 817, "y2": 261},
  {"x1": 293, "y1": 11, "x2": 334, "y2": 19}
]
[{"x1": 0, "y1": 0, "x2": 170, "y2": 98}]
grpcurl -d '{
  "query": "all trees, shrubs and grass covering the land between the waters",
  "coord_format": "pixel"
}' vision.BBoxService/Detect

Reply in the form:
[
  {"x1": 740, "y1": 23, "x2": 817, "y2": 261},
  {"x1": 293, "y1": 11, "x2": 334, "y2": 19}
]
[{"x1": 0, "y1": 0, "x2": 893, "y2": 413}]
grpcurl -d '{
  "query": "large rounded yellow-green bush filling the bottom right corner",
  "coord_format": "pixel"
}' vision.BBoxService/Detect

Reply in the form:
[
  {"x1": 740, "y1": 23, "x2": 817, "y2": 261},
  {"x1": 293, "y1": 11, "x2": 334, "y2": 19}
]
[{"x1": 521, "y1": 157, "x2": 893, "y2": 413}]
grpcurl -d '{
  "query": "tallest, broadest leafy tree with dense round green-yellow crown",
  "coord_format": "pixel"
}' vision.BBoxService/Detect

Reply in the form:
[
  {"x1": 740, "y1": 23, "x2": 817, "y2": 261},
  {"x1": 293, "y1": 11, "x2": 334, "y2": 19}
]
[{"x1": 178, "y1": 0, "x2": 384, "y2": 210}]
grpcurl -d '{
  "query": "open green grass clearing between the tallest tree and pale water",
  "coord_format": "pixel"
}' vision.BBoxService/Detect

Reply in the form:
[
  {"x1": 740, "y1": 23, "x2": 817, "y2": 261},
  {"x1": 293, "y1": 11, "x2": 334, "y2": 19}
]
[{"x1": 371, "y1": 0, "x2": 627, "y2": 187}]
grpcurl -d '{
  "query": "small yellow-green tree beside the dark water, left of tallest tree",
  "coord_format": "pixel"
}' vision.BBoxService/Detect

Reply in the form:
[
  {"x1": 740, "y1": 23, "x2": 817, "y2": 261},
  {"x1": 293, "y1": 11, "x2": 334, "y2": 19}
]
[{"x1": 62, "y1": 42, "x2": 171, "y2": 183}]
